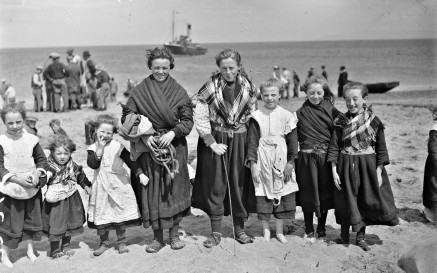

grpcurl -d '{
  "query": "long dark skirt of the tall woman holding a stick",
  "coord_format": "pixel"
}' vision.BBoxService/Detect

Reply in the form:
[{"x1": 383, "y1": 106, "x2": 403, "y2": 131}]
[{"x1": 192, "y1": 131, "x2": 256, "y2": 220}]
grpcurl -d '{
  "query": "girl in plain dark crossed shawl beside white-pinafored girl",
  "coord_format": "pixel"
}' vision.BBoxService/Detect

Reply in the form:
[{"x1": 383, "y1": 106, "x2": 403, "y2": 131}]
[{"x1": 296, "y1": 75, "x2": 339, "y2": 240}]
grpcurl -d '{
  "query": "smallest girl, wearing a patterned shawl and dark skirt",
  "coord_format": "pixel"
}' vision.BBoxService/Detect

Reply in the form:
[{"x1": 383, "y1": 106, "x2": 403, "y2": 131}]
[{"x1": 42, "y1": 135, "x2": 91, "y2": 258}]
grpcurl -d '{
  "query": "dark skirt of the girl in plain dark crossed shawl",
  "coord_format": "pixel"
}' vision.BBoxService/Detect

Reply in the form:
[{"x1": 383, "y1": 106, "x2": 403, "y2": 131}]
[{"x1": 296, "y1": 152, "x2": 334, "y2": 217}]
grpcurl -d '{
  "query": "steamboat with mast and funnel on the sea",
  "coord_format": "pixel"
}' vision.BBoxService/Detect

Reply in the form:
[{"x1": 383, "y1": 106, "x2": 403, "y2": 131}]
[{"x1": 164, "y1": 11, "x2": 207, "y2": 56}]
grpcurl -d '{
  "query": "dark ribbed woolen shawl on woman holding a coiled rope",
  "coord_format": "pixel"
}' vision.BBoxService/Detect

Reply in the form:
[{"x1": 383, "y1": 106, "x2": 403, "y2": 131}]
[{"x1": 126, "y1": 75, "x2": 190, "y2": 130}]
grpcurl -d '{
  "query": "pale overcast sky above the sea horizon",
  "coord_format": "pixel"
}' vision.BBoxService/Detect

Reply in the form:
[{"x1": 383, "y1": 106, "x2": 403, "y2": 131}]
[{"x1": 0, "y1": 0, "x2": 437, "y2": 48}]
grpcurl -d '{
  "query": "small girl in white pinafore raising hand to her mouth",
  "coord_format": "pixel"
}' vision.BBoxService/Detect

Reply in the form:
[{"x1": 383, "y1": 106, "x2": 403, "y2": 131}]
[{"x1": 87, "y1": 115, "x2": 147, "y2": 256}]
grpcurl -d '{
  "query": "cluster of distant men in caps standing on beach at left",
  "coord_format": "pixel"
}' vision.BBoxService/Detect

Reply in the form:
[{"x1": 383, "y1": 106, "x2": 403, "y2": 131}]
[{"x1": 31, "y1": 48, "x2": 118, "y2": 112}]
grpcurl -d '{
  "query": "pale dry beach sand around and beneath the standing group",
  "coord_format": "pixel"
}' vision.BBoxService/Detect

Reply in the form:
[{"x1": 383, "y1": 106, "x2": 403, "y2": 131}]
[{"x1": 0, "y1": 91, "x2": 437, "y2": 273}]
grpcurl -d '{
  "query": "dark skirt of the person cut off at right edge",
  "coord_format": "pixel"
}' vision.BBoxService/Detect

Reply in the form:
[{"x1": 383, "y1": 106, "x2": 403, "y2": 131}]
[{"x1": 423, "y1": 155, "x2": 437, "y2": 209}]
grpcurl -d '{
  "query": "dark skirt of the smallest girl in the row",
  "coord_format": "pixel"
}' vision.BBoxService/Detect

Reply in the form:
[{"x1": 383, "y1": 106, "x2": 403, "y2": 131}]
[{"x1": 42, "y1": 191, "x2": 86, "y2": 241}]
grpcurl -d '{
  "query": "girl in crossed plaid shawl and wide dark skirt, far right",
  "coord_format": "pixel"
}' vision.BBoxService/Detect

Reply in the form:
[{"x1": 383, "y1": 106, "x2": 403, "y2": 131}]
[{"x1": 328, "y1": 82, "x2": 399, "y2": 251}]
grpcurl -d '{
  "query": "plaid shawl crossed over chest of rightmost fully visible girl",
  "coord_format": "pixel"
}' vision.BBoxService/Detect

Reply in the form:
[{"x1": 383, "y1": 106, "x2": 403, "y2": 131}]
[{"x1": 334, "y1": 106, "x2": 381, "y2": 151}]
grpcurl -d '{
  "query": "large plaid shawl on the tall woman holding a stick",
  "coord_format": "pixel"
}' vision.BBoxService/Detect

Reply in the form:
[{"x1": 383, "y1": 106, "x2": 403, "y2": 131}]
[{"x1": 198, "y1": 73, "x2": 258, "y2": 129}]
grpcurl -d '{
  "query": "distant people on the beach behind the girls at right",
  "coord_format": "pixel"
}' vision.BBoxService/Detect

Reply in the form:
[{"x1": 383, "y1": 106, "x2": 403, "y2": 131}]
[{"x1": 272, "y1": 65, "x2": 349, "y2": 99}]
